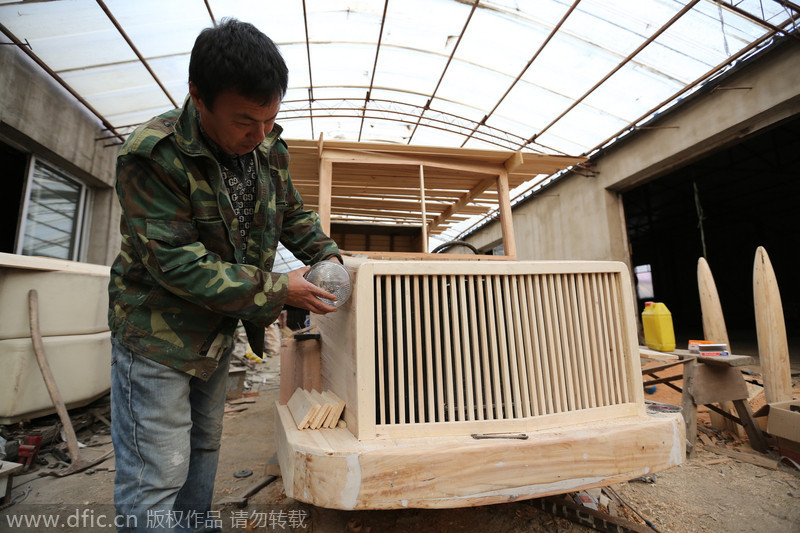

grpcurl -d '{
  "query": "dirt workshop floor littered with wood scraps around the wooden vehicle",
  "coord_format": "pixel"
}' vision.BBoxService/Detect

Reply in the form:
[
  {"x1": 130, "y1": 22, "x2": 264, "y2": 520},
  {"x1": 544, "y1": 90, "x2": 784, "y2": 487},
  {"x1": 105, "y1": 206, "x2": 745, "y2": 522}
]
[{"x1": 0, "y1": 357, "x2": 800, "y2": 533}]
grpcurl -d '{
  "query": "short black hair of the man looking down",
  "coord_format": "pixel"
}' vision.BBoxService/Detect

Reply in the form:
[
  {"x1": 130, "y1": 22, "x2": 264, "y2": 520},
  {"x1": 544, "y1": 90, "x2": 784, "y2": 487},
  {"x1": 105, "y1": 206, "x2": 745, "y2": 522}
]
[{"x1": 189, "y1": 18, "x2": 289, "y2": 109}]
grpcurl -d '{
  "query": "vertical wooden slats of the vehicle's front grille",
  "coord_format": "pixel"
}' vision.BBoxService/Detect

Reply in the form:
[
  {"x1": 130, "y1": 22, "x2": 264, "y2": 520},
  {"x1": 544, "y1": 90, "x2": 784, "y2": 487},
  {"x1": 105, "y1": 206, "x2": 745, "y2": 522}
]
[{"x1": 374, "y1": 273, "x2": 632, "y2": 425}]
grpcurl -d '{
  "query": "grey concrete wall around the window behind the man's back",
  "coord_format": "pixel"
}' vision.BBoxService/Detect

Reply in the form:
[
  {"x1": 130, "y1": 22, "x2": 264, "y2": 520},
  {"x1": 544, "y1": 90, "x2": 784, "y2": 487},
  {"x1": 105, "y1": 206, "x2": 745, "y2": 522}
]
[{"x1": 0, "y1": 46, "x2": 119, "y2": 264}]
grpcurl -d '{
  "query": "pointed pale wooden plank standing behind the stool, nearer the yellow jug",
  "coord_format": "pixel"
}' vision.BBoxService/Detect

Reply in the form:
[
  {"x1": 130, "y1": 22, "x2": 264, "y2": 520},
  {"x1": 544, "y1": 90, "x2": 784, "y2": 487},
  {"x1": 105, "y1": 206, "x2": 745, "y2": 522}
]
[{"x1": 697, "y1": 257, "x2": 740, "y2": 435}]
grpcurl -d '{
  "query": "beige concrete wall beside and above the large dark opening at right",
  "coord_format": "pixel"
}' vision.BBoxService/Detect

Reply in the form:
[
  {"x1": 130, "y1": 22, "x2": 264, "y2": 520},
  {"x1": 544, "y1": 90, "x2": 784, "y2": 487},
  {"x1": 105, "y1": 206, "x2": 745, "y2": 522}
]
[{"x1": 467, "y1": 39, "x2": 800, "y2": 264}]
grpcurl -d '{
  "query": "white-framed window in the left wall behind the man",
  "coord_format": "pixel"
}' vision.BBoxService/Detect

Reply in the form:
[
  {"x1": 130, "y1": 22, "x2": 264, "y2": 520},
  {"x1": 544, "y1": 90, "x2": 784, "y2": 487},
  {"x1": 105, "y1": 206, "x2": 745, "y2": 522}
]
[{"x1": 15, "y1": 157, "x2": 88, "y2": 261}]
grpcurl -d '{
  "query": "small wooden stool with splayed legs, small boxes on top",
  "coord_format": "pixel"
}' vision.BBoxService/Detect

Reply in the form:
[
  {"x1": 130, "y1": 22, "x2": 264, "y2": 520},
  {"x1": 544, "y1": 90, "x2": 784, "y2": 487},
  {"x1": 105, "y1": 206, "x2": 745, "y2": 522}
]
[{"x1": 681, "y1": 355, "x2": 767, "y2": 457}]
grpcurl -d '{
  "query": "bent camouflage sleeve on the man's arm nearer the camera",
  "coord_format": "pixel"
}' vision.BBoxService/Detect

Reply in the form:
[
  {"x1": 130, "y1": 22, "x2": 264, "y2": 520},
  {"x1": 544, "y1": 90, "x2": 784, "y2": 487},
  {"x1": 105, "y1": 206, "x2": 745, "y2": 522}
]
[{"x1": 116, "y1": 155, "x2": 289, "y2": 325}]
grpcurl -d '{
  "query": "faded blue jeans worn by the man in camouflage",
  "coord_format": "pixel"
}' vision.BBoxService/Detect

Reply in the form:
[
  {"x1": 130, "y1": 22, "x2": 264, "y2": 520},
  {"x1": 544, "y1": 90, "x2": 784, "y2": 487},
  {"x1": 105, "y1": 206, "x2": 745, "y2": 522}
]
[{"x1": 111, "y1": 339, "x2": 231, "y2": 531}]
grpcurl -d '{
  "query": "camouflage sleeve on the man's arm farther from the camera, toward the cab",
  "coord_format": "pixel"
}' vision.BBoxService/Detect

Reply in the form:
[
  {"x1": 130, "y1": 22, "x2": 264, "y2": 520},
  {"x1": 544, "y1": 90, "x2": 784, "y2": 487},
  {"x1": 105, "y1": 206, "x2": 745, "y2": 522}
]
[{"x1": 281, "y1": 170, "x2": 342, "y2": 265}]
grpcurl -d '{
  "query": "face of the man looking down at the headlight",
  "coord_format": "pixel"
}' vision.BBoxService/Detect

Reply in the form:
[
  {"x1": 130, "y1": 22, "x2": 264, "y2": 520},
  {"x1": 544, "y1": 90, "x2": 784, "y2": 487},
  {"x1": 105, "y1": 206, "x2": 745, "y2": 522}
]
[{"x1": 189, "y1": 83, "x2": 281, "y2": 155}]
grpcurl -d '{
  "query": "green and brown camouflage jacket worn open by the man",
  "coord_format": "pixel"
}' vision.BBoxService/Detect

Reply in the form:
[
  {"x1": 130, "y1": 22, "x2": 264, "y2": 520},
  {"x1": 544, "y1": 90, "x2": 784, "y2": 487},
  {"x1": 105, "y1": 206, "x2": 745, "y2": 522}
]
[{"x1": 109, "y1": 95, "x2": 339, "y2": 379}]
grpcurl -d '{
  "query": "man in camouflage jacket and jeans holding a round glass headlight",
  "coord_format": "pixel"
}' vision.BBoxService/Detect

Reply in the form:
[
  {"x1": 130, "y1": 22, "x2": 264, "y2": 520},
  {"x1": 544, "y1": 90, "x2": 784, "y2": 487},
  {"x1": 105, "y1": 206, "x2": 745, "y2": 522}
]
[{"x1": 109, "y1": 20, "x2": 341, "y2": 531}]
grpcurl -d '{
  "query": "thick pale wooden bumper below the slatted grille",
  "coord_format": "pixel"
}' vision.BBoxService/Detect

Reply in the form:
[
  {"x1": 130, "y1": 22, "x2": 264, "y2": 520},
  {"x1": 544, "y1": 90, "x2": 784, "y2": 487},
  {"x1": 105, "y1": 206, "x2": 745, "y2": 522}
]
[{"x1": 276, "y1": 404, "x2": 685, "y2": 509}]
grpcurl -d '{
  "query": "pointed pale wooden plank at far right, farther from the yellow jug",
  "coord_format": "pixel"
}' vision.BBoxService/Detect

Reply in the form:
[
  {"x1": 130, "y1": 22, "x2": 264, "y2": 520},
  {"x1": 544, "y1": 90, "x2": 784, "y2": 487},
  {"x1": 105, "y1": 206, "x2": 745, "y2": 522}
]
[{"x1": 753, "y1": 246, "x2": 792, "y2": 403}]
